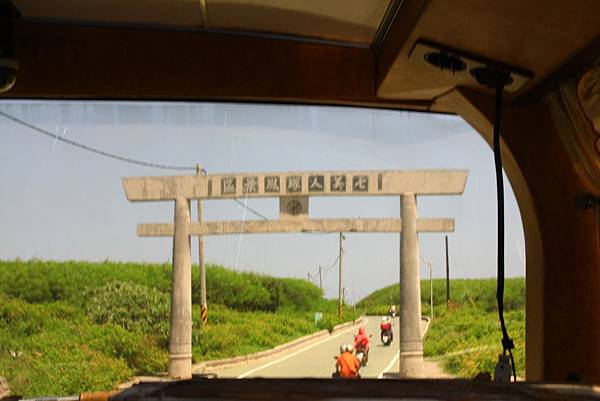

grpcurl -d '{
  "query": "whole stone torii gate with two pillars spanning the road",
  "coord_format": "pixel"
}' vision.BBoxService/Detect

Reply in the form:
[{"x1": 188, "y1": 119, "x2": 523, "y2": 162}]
[{"x1": 122, "y1": 170, "x2": 468, "y2": 379}]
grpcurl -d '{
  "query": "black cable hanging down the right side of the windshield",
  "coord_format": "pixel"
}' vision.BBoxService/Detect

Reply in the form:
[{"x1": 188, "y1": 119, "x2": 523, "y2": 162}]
[{"x1": 494, "y1": 86, "x2": 517, "y2": 382}]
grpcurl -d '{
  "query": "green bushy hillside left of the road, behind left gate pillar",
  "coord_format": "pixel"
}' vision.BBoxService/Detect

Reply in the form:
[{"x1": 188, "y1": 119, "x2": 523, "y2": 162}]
[{"x1": 0, "y1": 260, "x2": 357, "y2": 396}]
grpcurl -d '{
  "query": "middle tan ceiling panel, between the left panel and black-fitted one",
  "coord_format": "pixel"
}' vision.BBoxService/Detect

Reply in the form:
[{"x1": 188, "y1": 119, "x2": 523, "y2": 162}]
[{"x1": 206, "y1": 0, "x2": 390, "y2": 45}]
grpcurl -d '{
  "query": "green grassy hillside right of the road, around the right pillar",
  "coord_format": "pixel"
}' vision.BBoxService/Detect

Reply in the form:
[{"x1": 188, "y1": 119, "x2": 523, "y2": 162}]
[{"x1": 359, "y1": 278, "x2": 525, "y2": 377}]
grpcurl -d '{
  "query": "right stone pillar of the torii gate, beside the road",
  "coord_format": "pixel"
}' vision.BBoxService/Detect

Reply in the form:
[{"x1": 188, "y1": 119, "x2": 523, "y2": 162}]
[{"x1": 400, "y1": 193, "x2": 423, "y2": 378}]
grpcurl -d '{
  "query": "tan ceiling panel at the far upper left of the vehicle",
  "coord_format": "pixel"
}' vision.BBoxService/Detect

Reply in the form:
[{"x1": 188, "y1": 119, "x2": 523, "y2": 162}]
[{"x1": 13, "y1": 0, "x2": 202, "y2": 27}]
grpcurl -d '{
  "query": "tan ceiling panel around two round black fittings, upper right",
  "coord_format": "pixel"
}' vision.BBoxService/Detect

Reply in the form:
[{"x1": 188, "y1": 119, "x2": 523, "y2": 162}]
[{"x1": 378, "y1": 0, "x2": 600, "y2": 99}]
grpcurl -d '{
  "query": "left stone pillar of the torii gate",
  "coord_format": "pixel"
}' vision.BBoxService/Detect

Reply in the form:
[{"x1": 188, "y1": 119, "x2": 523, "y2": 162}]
[{"x1": 168, "y1": 198, "x2": 192, "y2": 380}]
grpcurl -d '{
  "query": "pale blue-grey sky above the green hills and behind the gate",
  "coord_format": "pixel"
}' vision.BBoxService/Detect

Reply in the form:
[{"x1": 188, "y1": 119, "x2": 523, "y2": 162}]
[{"x1": 0, "y1": 101, "x2": 524, "y2": 297}]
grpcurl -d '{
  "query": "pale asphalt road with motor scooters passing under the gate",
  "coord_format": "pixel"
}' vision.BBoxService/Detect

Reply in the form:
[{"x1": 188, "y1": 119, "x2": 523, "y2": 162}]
[{"x1": 215, "y1": 316, "x2": 424, "y2": 379}]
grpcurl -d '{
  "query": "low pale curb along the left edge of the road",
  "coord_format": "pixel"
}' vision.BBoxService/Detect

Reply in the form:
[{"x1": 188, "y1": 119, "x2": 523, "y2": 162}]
[{"x1": 192, "y1": 317, "x2": 363, "y2": 373}]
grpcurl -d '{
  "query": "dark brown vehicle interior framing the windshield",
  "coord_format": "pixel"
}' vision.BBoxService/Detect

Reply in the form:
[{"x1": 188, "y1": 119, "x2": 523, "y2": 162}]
[{"x1": 0, "y1": 0, "x2": 600, "y2": 400}]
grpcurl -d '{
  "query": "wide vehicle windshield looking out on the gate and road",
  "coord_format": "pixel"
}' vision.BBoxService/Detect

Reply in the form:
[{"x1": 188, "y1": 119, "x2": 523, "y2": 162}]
[{"x1": 0, "y1": 101, "x2": 525, "y2": 396}]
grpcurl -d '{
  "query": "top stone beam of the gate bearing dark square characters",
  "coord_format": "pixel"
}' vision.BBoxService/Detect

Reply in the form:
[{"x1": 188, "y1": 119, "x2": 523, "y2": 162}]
[{"x1": 123, "y1": 170, "x2": 469, "y2": 202}]
